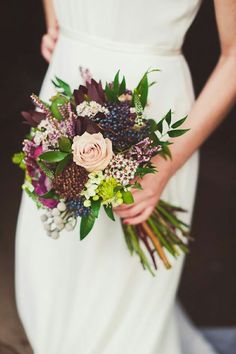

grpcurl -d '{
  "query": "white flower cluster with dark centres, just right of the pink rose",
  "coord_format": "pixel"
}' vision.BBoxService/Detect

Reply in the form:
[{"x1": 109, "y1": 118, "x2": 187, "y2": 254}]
[{"x1": 104, "y1": 154, "x2": 138, "y2": 186}]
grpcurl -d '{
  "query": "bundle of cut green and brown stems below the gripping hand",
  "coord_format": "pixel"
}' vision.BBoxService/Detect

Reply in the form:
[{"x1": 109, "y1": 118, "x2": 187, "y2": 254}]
[{"x1": 122, "y1": 200, "x2": 190, "y2": 275}]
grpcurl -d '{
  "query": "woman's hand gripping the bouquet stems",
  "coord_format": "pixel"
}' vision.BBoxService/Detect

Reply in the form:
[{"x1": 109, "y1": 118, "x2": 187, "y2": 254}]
[{"x1": 114, "y1": 156, "x2": 171, "y2": 225}]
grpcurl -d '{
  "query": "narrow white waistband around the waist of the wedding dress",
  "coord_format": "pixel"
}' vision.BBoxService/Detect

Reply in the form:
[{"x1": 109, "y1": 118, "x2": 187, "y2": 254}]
[{"x1": 60, "y1": 26, "x2": 181, "y2": 56}]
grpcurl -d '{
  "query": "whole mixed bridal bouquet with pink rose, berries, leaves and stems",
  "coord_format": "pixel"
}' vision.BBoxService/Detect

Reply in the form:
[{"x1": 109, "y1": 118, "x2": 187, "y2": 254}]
[{"x1": 13, "y1": 69, "x2": 189, "y2": 275}]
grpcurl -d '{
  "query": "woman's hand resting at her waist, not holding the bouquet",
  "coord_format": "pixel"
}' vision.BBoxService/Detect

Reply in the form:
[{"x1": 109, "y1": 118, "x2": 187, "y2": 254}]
[{"x1": 41, "y1": 26, "x2": 59, "y2": 63}]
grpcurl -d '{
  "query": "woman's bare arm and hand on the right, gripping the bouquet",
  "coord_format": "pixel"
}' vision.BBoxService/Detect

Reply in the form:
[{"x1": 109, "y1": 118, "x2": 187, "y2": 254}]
[{"x1": 116, "y1": 0, "x2": 236, "y2": 224}]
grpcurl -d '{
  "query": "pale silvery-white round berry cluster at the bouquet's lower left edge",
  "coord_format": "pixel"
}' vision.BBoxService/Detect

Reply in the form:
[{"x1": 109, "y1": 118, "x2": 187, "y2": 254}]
[{"x1": 41, "y1": 201, "x2": 76, "y2": 239}]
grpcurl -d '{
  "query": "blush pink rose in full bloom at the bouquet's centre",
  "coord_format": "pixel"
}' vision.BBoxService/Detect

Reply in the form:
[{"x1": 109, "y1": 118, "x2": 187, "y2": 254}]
[{"x1": 72, "y1": 132, "x2": 113, "y2": 172}]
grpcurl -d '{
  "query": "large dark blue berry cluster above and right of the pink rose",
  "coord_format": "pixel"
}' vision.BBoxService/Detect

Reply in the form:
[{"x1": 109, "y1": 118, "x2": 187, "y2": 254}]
[{"x1": 95, "y1": 102, "x2": 150, "y2": 151}]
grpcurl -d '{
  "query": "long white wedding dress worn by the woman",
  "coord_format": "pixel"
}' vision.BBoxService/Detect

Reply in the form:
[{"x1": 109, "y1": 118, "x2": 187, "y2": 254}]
[{"x1": 16, "y1": 0, "x2": 218, "y2": 354}]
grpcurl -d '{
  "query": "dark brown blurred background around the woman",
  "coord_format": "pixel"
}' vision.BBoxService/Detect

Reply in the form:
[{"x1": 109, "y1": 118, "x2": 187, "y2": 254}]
[{"x1": 0, "y1": 0, "x2": 236, "y2": 354}]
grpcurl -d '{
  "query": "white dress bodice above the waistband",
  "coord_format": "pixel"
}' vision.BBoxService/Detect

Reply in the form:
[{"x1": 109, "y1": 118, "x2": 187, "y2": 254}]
[{"x1": 54, "y1": 0, "x2": 201, "y2": 51}]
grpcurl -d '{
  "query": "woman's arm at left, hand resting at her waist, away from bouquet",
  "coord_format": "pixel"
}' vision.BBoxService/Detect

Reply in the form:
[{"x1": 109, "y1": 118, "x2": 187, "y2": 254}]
[{"x1": 41, "y1": 0, "x2": 59, "y2": 62}]
